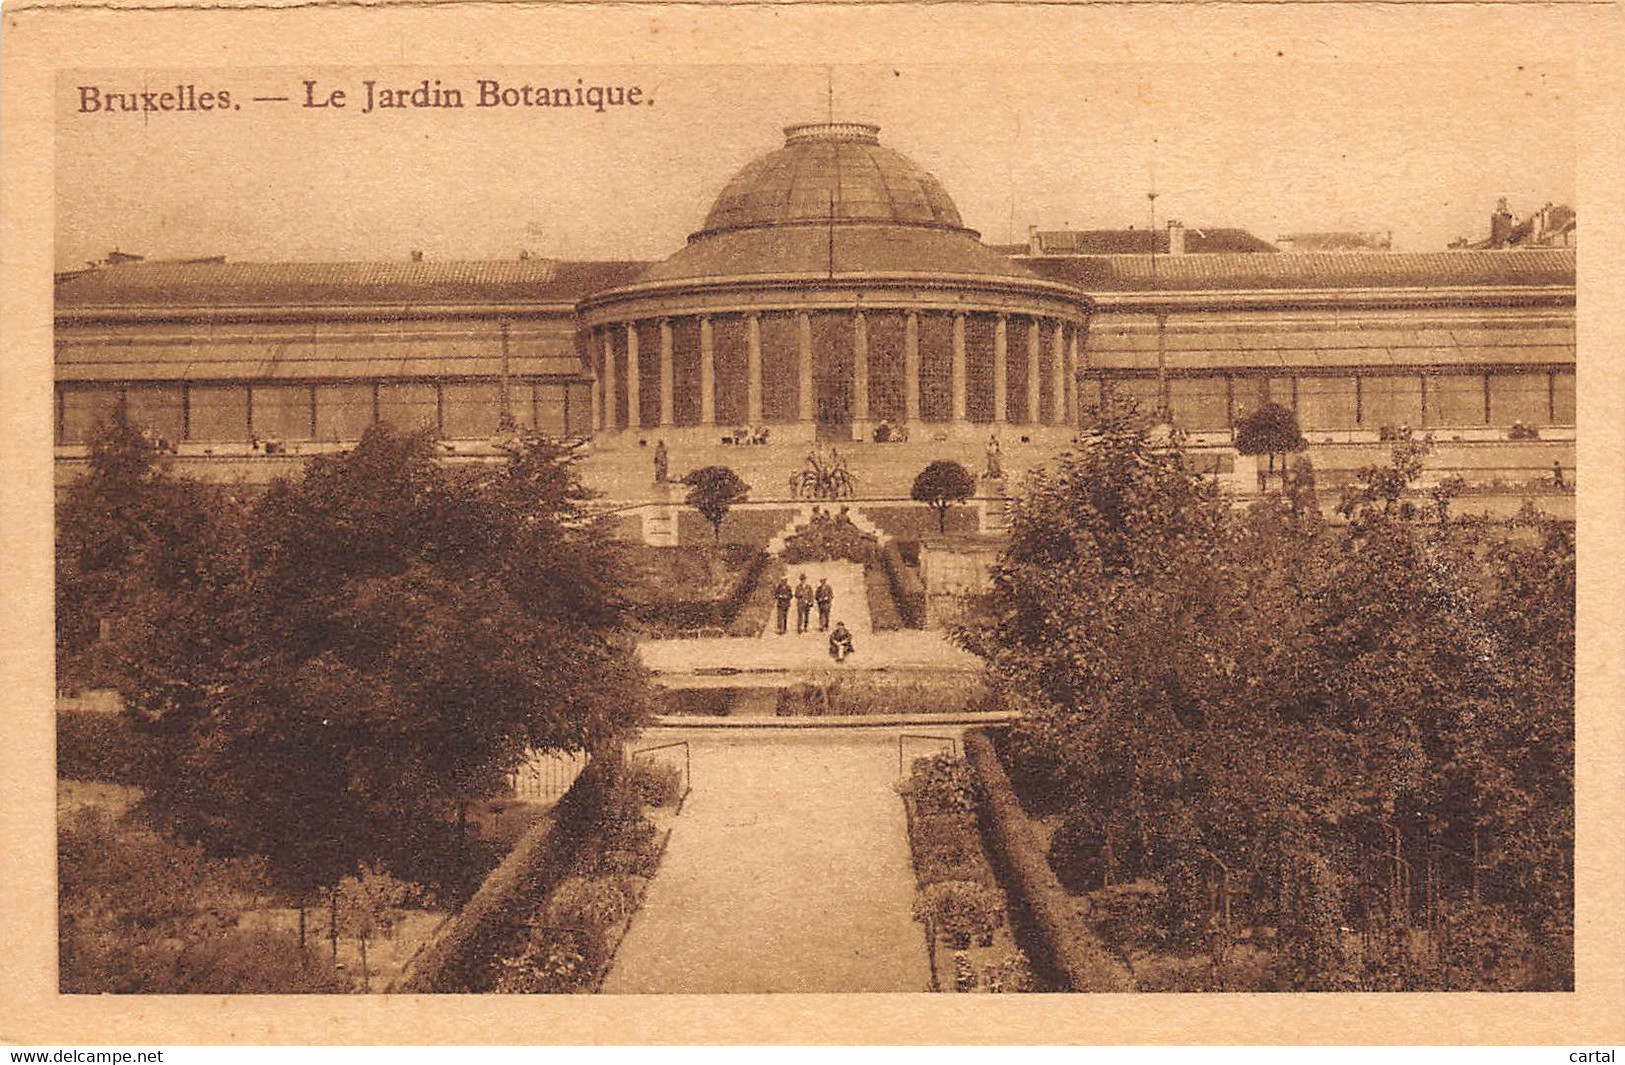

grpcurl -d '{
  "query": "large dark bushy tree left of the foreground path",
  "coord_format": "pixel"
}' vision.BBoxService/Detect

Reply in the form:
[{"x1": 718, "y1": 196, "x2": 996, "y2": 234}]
[{"x1": 104, "y1": 426, "x2": 647, "y2": 906}]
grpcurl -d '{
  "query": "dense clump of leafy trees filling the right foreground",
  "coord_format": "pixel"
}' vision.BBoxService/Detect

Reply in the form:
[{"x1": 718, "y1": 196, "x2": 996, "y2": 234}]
[{"x1": 959, "y1": 399, "x2": 1573, "y2": 989}]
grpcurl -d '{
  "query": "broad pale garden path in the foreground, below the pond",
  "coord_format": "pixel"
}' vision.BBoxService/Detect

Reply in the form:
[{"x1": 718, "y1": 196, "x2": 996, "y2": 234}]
[{"x1": 603, "y1": 728, "x2": 931, "y2": 993}]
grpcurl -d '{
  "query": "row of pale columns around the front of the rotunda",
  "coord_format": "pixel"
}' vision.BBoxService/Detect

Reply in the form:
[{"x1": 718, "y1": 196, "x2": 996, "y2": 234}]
[{"x1": 590, "y1": 311, "x2": 1081, "y2": 431}]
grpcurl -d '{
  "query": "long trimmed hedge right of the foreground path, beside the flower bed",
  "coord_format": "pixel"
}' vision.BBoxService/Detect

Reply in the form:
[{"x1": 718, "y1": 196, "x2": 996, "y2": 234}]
[{"x1": 965, "y1": 728, "x2": 1134, "y2": 992}]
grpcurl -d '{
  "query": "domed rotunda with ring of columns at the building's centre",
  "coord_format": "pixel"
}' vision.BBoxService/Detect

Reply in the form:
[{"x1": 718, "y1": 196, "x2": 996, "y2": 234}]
[{"x1": 579, "y1": 122, "x2": 1089, "y2": 442}]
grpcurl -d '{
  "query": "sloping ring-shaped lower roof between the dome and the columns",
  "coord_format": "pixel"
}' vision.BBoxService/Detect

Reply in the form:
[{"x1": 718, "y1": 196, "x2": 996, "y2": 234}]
[{"x1": 639, "y1": 223, "x2": 1034, "y2": 281}]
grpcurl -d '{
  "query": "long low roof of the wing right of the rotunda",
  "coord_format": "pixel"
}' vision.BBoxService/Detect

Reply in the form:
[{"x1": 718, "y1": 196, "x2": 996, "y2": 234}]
[{"x1": 1019, "y1": 249, "x2": 1575, "y2": 293}]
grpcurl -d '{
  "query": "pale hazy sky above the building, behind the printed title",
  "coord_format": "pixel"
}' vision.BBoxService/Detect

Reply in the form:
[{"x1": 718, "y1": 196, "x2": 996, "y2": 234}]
[{"x1": 55, "y1": 61, "x2": 1576, "y2": 268}]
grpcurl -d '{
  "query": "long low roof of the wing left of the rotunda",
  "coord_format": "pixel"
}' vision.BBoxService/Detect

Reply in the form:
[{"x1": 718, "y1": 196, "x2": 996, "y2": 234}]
[{"x1": 57, "y1": 259, "x2": 645, "y2": 309}]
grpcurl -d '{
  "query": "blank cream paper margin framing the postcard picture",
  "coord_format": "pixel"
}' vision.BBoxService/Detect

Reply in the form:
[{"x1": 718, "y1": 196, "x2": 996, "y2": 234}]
[{"x1": 0, "y1": 0, "x2": 1625, "y2": 1047}]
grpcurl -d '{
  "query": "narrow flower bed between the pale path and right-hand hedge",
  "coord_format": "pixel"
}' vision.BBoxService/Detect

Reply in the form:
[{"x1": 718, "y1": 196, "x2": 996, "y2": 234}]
[{"x1": 899, "y1": 754, "x2": 1040, "y2": 992}]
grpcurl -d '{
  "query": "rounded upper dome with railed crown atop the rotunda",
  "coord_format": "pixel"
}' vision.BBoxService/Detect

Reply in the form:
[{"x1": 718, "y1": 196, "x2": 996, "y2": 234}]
[{"x1": 696, "y1": 122, "x2": 964, "y2": 236}]
